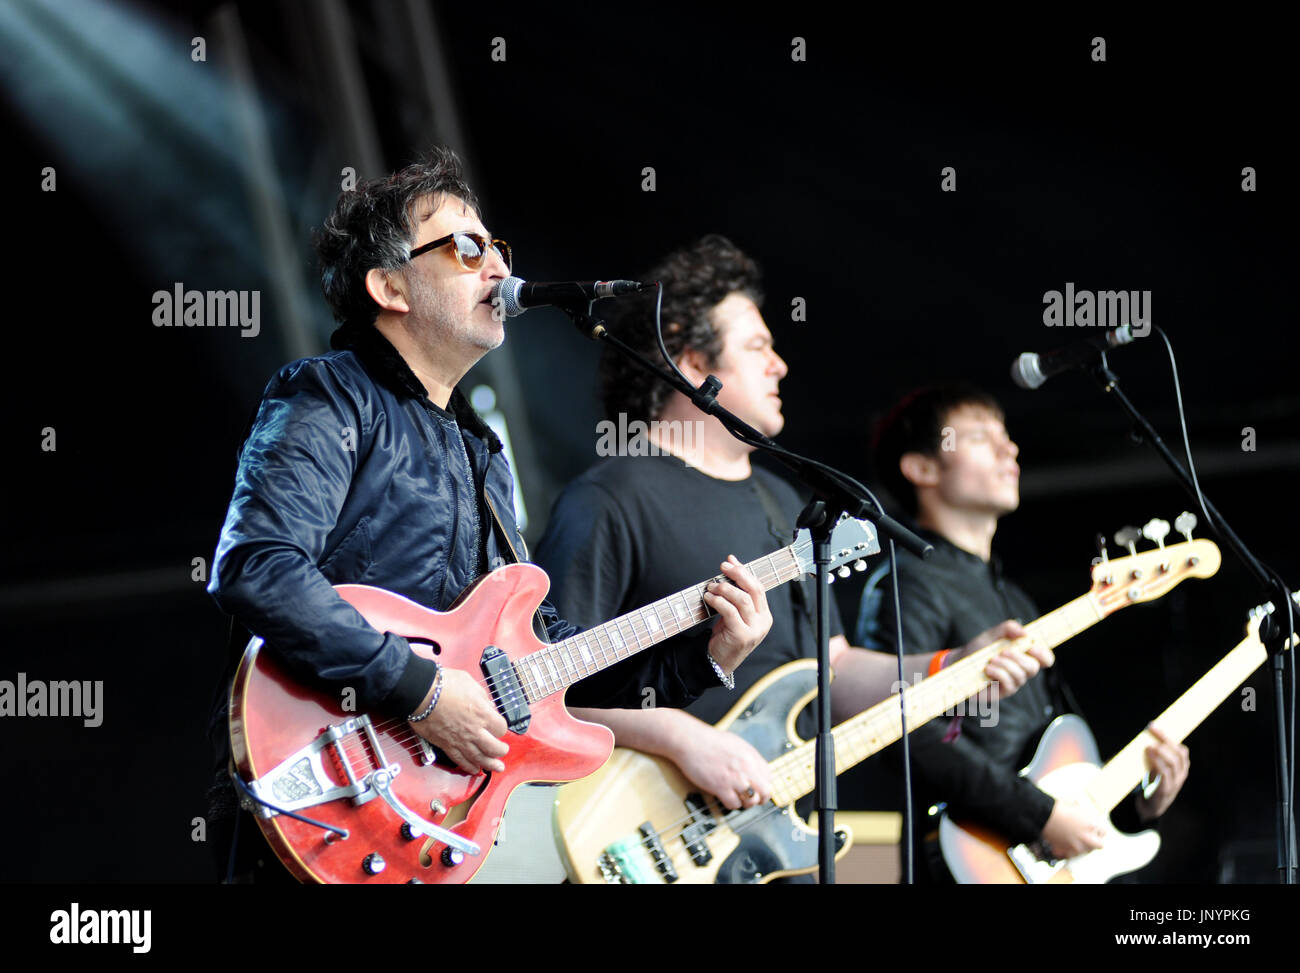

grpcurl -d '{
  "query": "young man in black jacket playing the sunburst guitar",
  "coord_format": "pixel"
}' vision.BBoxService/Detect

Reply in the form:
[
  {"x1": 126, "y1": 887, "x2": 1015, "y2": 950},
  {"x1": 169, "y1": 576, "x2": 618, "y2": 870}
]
[{"x1": 855, "y1": 384, "x2": 1188, "y2": 882}]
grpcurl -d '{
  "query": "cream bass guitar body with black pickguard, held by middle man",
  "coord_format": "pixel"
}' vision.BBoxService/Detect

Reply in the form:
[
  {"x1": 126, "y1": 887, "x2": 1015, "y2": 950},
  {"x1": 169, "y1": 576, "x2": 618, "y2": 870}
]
[{"x1": 555, "y1": 660, "x2": 852, "y2": 885}]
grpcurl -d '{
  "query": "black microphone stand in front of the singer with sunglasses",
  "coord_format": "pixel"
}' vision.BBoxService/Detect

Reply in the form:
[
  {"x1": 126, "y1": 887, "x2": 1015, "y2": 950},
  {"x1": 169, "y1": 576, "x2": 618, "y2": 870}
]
[{"x1": 556, "y1": 302, "x2": 933, "y2": 885}]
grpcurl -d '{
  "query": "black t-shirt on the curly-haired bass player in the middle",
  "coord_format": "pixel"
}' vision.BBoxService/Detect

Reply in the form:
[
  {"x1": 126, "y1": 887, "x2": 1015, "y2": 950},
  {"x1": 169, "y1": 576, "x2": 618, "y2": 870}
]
[{"x1": 533, "y1": 455, "x2": 844, "y2": 735}]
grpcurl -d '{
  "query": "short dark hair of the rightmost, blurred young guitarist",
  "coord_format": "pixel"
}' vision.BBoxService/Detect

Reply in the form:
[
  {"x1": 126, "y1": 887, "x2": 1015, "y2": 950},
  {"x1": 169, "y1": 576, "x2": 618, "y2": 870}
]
[{"x1": 871, "y1": 382, "x2": 1004, "y2": 516}]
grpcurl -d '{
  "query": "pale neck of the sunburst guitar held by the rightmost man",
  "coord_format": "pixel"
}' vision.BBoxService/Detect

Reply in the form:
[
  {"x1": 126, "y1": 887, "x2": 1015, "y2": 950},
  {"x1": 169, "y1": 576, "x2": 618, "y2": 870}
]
[{"x1": 1087, "y1": 632, "x2": 1268, "y2": 814}]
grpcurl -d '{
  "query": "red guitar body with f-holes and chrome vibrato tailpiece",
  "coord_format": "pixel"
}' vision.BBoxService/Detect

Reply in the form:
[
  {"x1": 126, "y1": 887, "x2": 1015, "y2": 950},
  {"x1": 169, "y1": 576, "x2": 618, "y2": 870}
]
[{"x1": 230, "y1": 565, "x2": 614, "y2": 883}]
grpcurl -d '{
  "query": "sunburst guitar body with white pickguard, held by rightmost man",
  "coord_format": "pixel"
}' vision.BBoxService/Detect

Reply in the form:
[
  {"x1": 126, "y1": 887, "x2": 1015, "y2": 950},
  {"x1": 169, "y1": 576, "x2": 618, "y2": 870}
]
[{"x1": 939, "y1": 715, "x2": 1160, "y2": 885}]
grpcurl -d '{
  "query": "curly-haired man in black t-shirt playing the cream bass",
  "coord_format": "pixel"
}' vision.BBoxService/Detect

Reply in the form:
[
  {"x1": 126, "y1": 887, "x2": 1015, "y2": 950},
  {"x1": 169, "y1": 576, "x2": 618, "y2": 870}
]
[{"x1": 537, "y1": 235, "x2": 1052, "y2": 822}]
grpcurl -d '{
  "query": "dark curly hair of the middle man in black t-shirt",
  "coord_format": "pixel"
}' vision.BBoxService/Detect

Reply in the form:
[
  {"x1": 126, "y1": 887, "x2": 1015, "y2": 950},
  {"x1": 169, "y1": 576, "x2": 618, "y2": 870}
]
[{"x1": 601, "y1": 233, "x2": 763, "y2": 420}]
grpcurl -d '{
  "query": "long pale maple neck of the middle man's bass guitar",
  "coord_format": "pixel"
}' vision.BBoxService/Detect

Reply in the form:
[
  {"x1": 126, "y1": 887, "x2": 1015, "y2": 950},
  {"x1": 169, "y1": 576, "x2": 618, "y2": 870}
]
[{"x1": 770, "y1": 592, "x2": 1105, "y2": 805}]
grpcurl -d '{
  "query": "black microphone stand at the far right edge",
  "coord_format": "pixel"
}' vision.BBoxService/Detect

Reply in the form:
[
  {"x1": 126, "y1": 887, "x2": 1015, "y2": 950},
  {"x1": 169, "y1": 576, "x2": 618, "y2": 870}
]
[{"x1": 1089, "y1": 351, "x2": 1296, "y2": 885}]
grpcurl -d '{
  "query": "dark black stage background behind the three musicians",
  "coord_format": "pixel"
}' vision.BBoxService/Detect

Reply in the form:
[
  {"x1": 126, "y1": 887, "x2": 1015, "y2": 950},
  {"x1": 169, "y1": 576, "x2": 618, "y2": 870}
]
[{"x1": 0, "y1": 3, "x2": 1300, "y2": 882}]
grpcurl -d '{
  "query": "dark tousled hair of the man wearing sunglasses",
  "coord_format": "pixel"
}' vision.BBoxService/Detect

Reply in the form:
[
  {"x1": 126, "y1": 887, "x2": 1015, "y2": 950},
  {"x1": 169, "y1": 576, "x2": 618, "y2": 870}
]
[{"x1": 312, "y1": 146, "x2": 478, "y2": 328}]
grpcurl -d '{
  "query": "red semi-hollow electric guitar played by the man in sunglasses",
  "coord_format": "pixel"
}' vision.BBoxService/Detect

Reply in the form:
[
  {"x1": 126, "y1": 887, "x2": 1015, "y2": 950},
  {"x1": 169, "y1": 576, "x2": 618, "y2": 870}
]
[{"x1": 230, "y1": 519, "x2": 880, "y2": 883}]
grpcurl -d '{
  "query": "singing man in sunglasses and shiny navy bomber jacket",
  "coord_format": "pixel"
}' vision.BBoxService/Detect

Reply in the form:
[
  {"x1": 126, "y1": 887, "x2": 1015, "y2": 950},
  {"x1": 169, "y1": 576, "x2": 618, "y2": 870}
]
[{"x1": 208, "y1": 148, "x2": 771, "y2": 881}]
